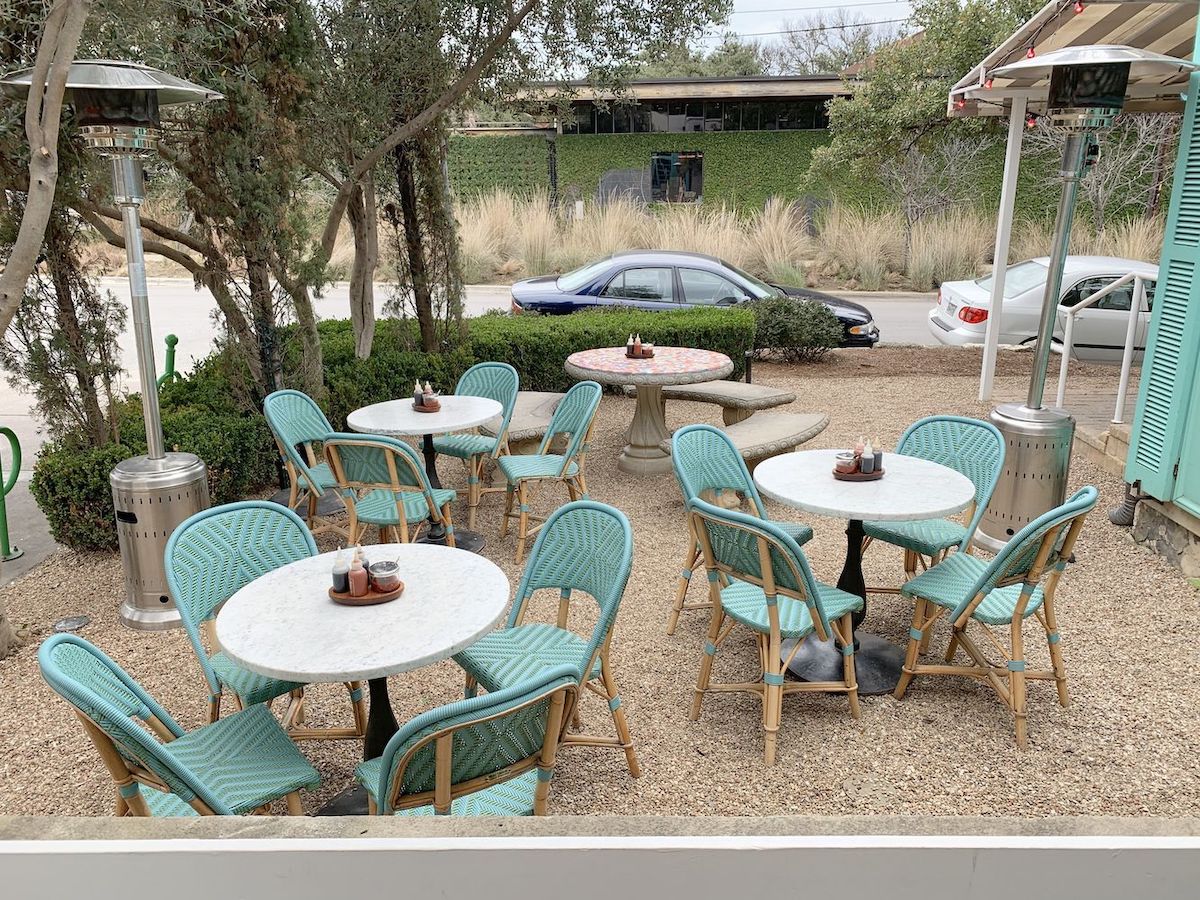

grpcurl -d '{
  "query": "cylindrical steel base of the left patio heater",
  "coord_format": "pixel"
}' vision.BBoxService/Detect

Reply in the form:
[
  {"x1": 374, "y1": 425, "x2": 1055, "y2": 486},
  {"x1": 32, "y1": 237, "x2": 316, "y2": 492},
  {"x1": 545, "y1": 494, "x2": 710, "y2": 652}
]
[{"x1": 109, "y1": 452, "x2": 209, "y2": 631}]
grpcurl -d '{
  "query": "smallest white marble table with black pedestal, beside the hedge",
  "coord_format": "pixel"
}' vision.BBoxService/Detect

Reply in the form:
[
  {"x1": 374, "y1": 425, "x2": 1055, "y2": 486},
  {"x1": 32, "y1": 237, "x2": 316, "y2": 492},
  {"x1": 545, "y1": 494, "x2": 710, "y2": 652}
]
[{"x1": 346, "y1": 394, "x2": 504, "y2": 553}]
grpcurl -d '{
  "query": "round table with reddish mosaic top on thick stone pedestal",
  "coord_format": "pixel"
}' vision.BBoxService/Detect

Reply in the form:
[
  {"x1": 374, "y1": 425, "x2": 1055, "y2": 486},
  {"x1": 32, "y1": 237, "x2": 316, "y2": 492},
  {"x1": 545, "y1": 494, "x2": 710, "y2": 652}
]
[{"x1": 564, "y1": 347, "x2": 733, "y2": 475}]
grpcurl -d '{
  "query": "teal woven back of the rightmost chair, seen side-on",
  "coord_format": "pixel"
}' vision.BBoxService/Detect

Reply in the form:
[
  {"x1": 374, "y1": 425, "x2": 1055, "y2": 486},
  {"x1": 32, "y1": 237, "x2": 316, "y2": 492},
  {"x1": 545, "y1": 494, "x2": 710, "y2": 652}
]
[{"x1": 952, "y1": 485, "x2": 1099, "y2": 620}]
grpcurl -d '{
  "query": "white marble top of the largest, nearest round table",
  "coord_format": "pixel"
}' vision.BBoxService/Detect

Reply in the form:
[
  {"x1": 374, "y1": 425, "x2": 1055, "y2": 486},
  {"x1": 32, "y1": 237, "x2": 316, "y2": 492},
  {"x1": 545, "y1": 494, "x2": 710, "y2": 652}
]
[{"x1": 216, "y1": 544, "x2": 509, "y2": 683}]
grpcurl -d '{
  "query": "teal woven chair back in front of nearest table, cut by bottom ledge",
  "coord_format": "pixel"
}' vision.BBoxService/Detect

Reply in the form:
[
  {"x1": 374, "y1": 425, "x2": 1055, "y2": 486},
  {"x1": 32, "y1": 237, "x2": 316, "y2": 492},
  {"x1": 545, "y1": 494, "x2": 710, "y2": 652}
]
[{"x1": 376, "y1": 665, "x2": 580, "y2": 815}]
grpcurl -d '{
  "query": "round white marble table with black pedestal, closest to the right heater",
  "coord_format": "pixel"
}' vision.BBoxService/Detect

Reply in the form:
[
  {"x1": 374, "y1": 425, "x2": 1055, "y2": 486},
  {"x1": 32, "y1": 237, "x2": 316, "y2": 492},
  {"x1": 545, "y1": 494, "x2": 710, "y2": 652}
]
[{"x1": 754, "y1": 450, "x2": 974, "y2": 695}]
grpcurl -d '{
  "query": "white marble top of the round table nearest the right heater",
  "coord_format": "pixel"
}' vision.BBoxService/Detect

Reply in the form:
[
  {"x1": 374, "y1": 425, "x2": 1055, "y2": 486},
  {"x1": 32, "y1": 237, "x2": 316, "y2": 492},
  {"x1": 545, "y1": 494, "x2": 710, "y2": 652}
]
[{"x1": 754, "y1": 450, "x2": 974, "y2": 521}]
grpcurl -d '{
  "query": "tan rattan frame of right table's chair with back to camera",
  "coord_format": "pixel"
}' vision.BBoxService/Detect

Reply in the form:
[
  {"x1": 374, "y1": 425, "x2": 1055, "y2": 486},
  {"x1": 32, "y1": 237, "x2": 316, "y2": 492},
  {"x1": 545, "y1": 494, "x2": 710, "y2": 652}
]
[{"x1": 688, "y1": 499, "x2": 860, "y2": 766}]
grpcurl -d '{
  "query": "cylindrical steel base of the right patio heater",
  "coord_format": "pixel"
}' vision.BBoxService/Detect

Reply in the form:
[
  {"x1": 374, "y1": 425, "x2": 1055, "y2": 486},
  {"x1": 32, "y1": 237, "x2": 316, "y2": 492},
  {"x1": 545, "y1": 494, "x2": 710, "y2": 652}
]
[{"x1": 974, "y1": 403, "x2": 1075, "y2": 553}]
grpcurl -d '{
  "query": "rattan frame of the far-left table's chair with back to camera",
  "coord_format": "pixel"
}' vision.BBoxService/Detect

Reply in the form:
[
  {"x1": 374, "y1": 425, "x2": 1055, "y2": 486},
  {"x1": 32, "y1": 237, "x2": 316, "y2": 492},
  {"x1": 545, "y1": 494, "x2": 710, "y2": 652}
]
[{"x1": 325, "y1": 432, "x2": 455, "y2": 547}]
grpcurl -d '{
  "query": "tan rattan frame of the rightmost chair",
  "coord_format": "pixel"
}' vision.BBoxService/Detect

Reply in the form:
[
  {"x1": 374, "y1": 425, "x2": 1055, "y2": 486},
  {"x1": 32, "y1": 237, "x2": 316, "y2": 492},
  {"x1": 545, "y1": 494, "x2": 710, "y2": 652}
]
[{"x1": 894, "y1": 488, "x2": 1096, "y2": 750}]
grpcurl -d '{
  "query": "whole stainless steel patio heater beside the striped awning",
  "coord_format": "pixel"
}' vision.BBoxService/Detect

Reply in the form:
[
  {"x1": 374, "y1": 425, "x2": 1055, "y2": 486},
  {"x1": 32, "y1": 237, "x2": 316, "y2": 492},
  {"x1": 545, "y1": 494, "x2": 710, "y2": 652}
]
[{"x1": 974, "y1": 46, "x2": 1192, "y2": 552}]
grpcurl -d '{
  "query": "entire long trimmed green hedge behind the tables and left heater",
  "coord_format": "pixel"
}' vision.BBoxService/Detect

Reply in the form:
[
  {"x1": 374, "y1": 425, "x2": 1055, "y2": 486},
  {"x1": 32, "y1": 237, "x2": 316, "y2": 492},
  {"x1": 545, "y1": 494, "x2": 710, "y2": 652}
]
[{"x1": 32, "y1": 310, "x2": 755, "y2": 550}]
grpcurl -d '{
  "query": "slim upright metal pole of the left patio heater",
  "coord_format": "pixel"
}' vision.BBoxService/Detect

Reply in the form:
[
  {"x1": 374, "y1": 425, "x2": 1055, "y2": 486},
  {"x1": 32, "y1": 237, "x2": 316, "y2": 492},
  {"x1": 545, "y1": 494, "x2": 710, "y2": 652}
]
[{"x1": 112, "y1": 155, "x2": 166, "y2": 460}]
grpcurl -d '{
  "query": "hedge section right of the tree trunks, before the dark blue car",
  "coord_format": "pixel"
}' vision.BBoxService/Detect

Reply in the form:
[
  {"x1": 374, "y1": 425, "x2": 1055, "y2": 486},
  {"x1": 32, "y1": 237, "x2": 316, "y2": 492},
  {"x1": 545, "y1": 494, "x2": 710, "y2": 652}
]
[{"x1": 470, "y1": 310, "x2": 754, "y2": 391}]
